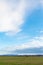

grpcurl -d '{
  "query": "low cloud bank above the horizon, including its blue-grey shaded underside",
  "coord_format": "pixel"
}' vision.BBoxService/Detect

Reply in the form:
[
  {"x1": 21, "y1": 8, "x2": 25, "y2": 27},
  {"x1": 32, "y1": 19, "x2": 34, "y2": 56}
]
[{"x1": 0, "y1": 36, "x2": 43, "y2": 55}]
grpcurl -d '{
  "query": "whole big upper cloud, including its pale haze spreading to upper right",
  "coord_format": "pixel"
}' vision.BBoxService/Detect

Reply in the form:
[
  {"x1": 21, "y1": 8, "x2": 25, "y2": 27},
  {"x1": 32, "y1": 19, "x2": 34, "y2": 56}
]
[{"x1": 0, "y1": 0, "x2": 38, "y2": 35}]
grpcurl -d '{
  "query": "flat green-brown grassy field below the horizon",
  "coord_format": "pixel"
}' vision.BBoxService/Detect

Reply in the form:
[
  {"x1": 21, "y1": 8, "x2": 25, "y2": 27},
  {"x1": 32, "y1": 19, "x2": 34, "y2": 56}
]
[{"x1": 0, "y1": 56, "x2": 43, "y2": 65}]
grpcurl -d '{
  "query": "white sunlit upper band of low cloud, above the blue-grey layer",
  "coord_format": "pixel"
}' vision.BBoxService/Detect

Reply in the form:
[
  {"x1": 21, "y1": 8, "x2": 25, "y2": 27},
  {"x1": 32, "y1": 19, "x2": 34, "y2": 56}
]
[{"x1": 3, "y1": 38, "x2": 43, "y2": 51}]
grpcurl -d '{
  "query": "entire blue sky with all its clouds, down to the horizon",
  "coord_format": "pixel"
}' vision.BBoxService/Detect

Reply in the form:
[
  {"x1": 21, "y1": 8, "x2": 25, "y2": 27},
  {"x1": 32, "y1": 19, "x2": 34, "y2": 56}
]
[{"x1": 0, "y1": 0, "x2": 43, "y2": 55}]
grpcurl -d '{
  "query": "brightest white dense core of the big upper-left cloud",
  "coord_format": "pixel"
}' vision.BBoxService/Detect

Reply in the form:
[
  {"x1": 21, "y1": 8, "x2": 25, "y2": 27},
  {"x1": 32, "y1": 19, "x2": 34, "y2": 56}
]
[{"x1": 0, "y1": 2, "x2": 24, "y2": 33}]
